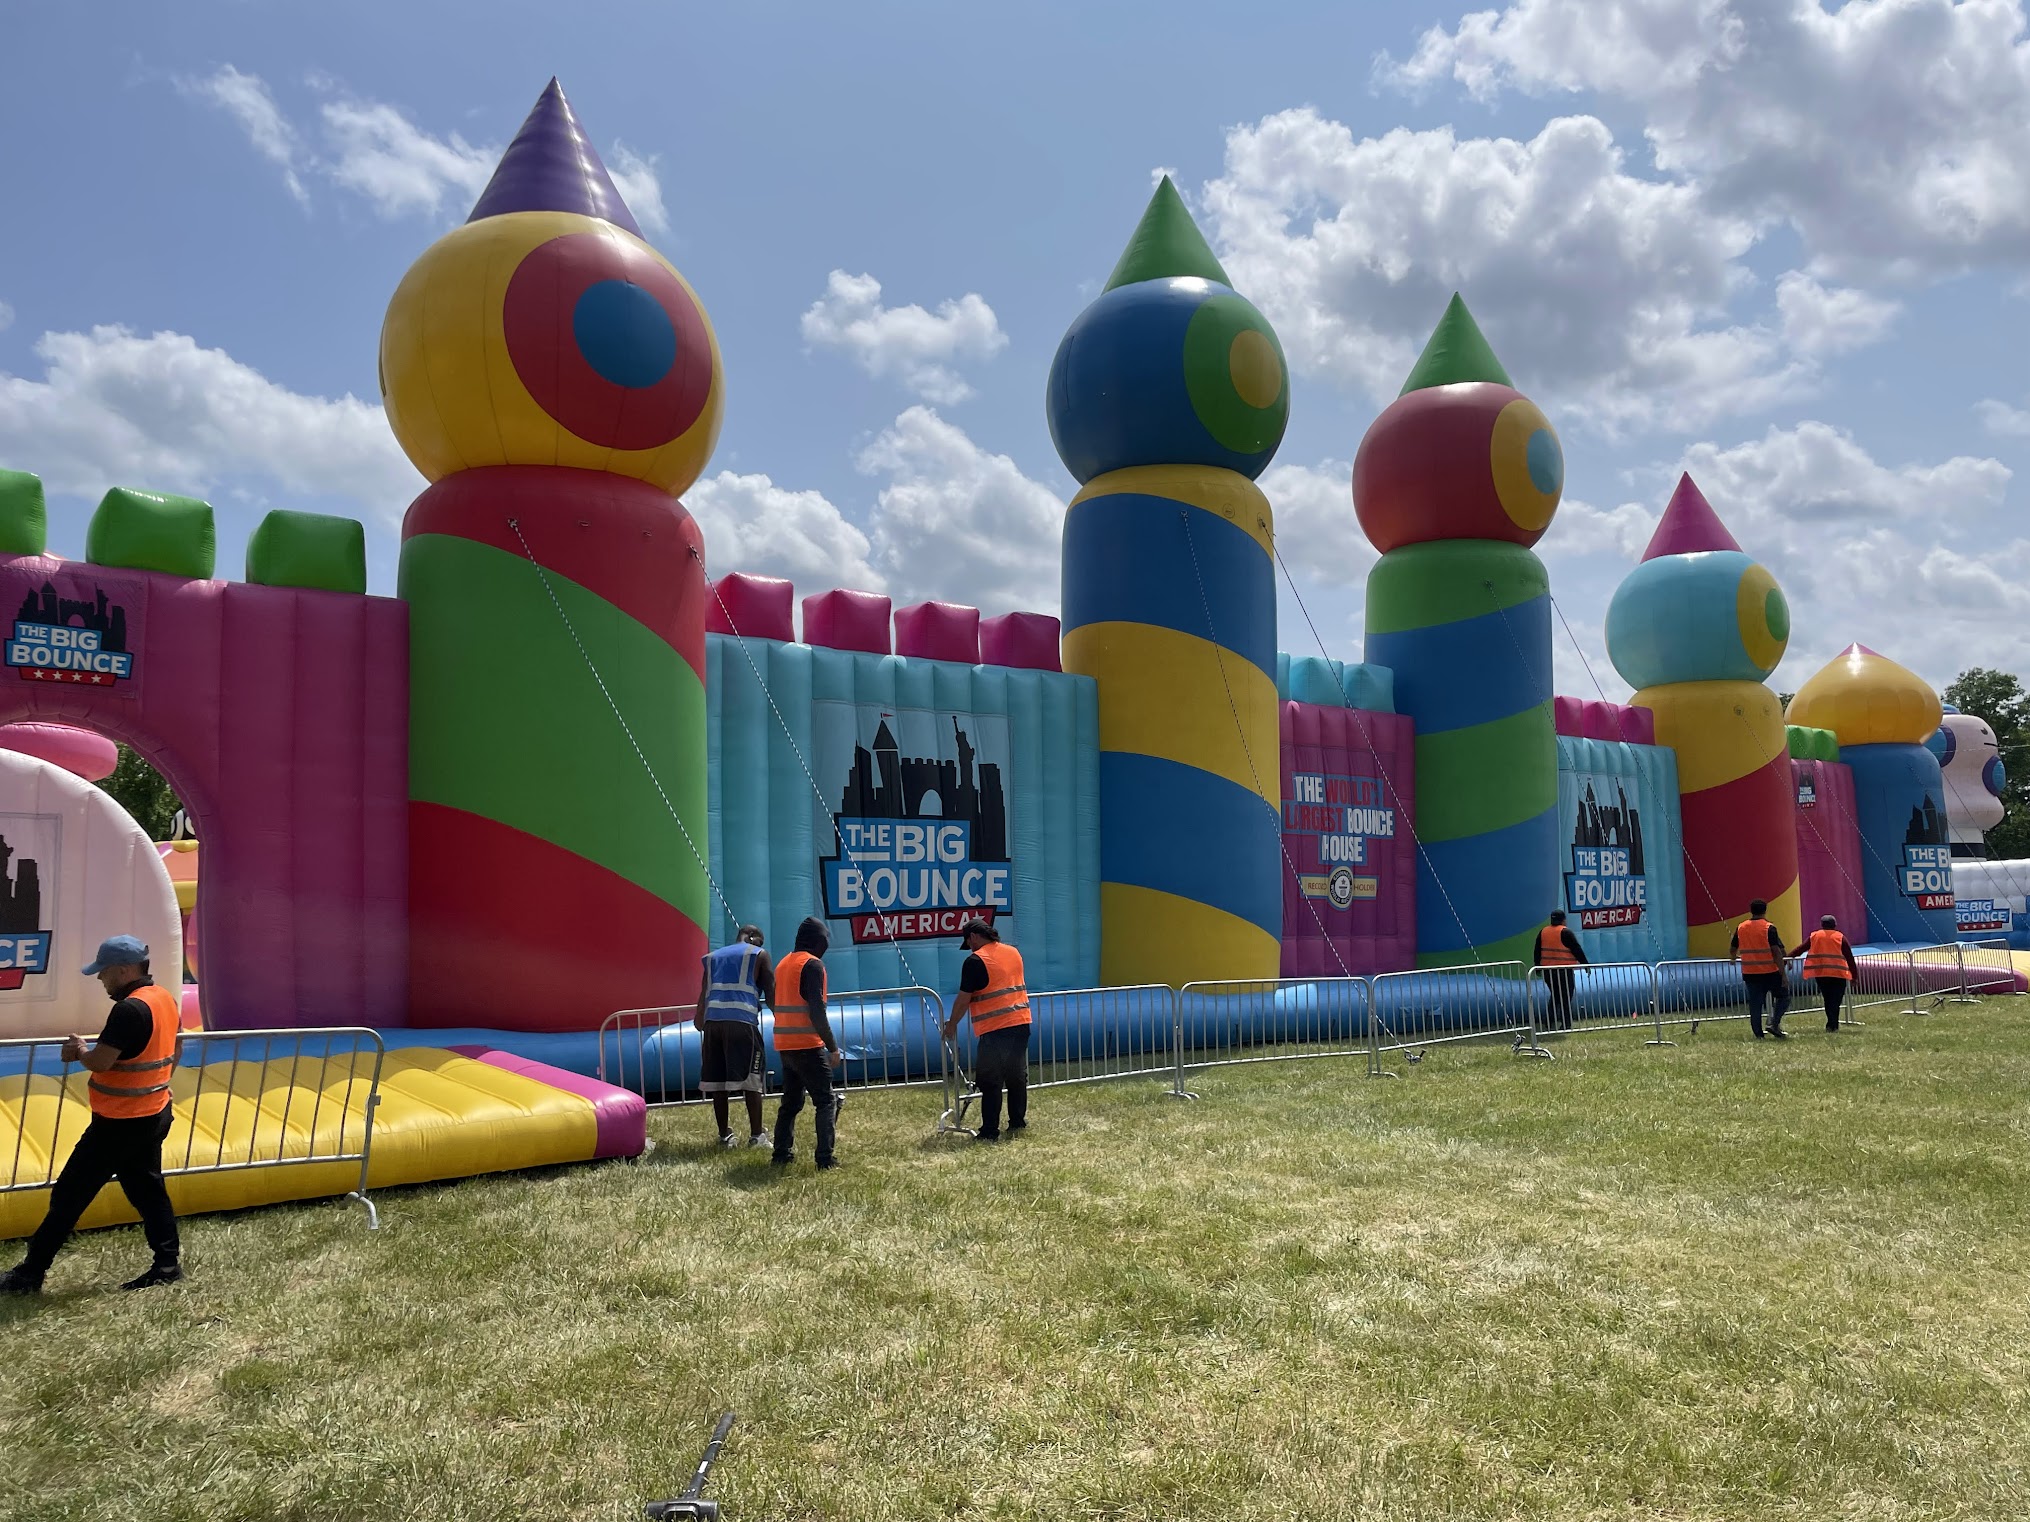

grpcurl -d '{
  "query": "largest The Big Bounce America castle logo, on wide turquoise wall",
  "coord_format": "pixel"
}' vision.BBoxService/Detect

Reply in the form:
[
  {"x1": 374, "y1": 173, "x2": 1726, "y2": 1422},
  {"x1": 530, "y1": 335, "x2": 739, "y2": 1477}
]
[{"x1": 816, "y1": 704, "x2": 1015, "y2": 944}]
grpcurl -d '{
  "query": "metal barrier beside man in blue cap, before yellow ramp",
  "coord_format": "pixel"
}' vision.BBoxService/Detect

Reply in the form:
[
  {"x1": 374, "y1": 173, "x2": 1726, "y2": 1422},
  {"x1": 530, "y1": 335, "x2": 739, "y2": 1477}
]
[{"x1": 0, "y1": 1027, "x2": 388, "y2": 1230}]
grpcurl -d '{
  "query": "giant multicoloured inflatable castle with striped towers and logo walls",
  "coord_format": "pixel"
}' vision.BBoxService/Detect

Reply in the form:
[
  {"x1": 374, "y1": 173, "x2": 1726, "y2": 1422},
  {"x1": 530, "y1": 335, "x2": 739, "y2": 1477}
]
[{"x1": 0, "y1": 81, "x2": 2020, "y2": 1071}]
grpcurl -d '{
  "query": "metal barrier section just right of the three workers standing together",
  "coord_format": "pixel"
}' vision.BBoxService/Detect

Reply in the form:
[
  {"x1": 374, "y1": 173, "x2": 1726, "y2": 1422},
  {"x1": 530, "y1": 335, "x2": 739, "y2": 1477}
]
[{"x1": 938, "y1": 984, "x2": 1181, "y2": 1134}]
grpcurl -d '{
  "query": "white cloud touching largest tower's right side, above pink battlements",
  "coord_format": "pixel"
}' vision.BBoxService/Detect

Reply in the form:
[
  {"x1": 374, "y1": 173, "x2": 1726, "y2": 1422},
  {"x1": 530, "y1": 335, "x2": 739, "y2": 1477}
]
[{"x1": 684, "y1": 471, "x2": 887, "y2": 593}]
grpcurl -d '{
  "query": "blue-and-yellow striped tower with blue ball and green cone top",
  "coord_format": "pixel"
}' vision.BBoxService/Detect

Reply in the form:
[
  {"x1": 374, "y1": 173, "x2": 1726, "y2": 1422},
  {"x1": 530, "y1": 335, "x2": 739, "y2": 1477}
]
[{"x1": 1047, "y1": 179, "x2": 1289, "y2": 986}]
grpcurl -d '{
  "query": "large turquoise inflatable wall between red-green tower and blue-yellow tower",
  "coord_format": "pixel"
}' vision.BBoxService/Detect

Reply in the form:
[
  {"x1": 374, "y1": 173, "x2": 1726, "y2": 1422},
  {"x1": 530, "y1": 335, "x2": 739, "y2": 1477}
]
[{"x1": 704, "y1": 635, "x2": 1100, "y2": 998}]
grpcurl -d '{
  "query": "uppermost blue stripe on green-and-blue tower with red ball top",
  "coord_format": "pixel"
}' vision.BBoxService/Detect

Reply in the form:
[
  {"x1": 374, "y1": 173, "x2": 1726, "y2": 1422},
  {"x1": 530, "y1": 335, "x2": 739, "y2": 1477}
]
[{"x1": 1366, "y1": 597, "x2": 1551, "y2": 735}]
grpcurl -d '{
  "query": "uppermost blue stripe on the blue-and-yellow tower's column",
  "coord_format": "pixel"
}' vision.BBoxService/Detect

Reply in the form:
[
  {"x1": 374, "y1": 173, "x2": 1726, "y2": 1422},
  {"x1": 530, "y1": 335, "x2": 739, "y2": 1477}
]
[{"x1": 1064, "y1": 491, "x2": 1275, "y2": 682}]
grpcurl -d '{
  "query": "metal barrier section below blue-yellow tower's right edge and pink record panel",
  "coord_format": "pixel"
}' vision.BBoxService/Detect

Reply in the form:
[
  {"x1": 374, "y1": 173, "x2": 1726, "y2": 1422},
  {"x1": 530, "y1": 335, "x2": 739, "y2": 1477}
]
[{"x1": 1175, "y1": 978, "x2": 1374, "y2": 1094}]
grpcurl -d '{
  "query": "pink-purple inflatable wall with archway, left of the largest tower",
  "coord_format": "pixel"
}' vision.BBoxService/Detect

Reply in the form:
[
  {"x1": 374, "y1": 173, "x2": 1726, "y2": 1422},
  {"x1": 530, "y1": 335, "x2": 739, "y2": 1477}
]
[{"x1": 0, "y1": 556, "x2": 408, "y2": 1029}]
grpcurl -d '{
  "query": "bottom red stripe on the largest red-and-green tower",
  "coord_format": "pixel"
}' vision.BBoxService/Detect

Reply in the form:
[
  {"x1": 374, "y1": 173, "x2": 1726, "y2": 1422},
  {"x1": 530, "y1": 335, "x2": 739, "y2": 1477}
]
[{"x1": 408, "y1": 802, "x2": 706, "y2": 1031}]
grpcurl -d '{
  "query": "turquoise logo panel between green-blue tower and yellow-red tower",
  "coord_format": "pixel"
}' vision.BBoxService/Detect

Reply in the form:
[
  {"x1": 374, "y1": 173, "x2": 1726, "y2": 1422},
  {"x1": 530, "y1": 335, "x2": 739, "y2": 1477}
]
[{"x1": 1557, "y1": 735, "x2": 1685, "y2": 962}]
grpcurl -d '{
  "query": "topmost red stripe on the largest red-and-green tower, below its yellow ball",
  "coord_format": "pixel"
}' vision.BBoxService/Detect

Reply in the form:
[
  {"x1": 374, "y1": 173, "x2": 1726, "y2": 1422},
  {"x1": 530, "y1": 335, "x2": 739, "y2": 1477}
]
[{"x1": 402, "y1": 465, "x2": 711, "y2": 682}]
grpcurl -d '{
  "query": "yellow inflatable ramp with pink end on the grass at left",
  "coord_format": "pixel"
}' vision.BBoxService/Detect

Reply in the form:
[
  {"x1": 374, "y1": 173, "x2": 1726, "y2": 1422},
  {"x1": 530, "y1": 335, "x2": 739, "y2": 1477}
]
[{"x1": 0, "y1": 1041, "x2": 648, "y2": 1240}]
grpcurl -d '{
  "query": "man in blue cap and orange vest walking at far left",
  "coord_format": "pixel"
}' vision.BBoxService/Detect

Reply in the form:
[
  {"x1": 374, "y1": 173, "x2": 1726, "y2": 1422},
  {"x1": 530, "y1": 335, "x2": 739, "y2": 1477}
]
[{"x1": 0, "y1": 936, "x2": 183, "y2": 1295}]
